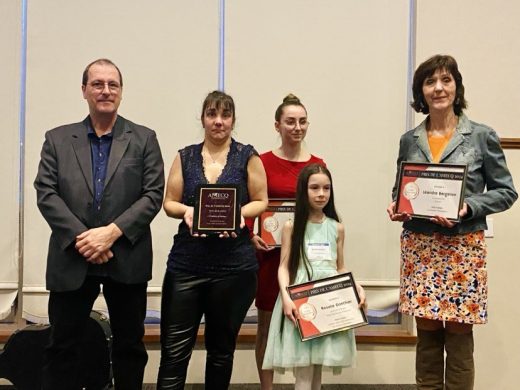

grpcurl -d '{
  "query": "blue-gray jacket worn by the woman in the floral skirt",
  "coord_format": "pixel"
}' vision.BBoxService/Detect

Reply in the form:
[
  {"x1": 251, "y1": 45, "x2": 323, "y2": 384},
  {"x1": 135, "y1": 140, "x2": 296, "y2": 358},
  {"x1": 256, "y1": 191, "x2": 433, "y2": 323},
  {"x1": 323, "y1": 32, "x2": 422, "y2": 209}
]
[{"x1": 392, "y1": 114, "x2": 518, "y2": 235}]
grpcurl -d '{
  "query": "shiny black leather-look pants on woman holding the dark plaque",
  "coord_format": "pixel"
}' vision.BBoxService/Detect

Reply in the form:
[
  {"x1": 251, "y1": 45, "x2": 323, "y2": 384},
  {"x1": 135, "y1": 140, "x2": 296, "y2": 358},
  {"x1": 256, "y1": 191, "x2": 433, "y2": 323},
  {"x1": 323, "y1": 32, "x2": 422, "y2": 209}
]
[{"x1": 157, "y1": 271, "x2": 256, "y2": 390}]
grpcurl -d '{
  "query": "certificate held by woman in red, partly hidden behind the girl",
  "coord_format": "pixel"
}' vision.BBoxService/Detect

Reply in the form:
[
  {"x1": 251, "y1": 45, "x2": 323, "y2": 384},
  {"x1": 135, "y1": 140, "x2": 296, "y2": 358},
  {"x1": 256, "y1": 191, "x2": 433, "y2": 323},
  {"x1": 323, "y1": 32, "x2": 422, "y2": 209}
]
[{"x1": 258, "y1": 199, "x2": 295, "y2": 247}]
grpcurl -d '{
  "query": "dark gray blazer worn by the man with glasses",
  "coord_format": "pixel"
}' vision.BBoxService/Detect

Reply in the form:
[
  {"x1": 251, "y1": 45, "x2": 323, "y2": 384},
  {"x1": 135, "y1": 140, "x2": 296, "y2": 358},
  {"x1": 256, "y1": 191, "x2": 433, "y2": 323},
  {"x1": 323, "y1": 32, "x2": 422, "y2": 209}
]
[{"x1": 34, "y1": 116, "x2": 164, "y2": 291}]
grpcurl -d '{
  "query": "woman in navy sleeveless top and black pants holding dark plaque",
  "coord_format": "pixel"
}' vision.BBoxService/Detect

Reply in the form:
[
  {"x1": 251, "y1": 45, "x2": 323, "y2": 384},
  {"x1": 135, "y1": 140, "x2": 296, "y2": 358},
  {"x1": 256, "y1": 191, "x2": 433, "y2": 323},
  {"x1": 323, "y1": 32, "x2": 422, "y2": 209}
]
[{"x1": 157, "y1": 91, "x2": 267, "y2": 389}]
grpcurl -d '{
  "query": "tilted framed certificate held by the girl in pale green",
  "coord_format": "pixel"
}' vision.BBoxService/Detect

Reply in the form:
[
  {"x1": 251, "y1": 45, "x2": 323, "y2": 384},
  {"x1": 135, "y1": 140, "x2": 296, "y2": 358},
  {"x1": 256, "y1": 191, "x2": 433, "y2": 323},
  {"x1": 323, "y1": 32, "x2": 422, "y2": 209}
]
[{"x1": 287, "y1": 272, "x2": 368, "y2": 341}]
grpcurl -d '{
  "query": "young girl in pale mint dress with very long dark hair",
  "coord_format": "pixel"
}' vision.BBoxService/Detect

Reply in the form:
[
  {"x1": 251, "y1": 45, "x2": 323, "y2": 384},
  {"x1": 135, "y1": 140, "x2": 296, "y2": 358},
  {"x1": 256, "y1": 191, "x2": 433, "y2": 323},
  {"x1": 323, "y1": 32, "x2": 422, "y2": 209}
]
[{"x1": 263, "y1": 164, "x2": 365, "y2": 390}]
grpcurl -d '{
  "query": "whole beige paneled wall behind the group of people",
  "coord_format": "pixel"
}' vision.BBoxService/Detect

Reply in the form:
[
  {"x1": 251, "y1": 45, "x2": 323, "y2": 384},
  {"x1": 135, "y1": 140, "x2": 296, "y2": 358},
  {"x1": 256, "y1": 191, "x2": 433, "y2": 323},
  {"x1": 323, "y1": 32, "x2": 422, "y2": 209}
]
[{"x1": 0, "y1": 0, "x2": 520, "y2": 390}]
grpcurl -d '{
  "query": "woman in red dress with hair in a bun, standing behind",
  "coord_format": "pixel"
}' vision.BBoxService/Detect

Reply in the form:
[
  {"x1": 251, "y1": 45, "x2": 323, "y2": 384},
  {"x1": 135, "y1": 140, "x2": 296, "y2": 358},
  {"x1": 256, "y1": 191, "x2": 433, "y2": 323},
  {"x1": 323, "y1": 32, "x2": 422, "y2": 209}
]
[{"x1": 248, "y1": 94, "x2": 325, "y2": 390}]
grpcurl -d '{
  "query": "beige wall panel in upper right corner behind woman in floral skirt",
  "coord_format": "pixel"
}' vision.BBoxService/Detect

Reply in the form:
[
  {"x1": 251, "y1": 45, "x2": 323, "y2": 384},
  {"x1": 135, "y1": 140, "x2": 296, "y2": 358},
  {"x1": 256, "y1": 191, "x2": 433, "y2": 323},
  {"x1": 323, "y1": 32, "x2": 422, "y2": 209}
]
[{"x1": 417, "y1": 0, "x2": 520, "y2": 137}]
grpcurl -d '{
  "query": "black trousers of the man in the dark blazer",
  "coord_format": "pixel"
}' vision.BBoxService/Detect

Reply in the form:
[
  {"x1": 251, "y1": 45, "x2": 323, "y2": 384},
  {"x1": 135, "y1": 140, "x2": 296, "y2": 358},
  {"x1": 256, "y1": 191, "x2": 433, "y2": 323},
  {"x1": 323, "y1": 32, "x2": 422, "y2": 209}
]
[{"x1": 42, "y1": 276, "x2": 148, "y2": 390}]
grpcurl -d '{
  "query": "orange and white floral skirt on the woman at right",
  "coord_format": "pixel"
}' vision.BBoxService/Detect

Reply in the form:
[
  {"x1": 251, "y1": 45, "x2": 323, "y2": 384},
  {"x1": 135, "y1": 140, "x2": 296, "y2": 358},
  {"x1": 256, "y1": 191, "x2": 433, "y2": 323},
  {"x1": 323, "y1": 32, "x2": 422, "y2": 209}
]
[{"x1": 399, "y1": 230, "x2": 487, "y2": 324}]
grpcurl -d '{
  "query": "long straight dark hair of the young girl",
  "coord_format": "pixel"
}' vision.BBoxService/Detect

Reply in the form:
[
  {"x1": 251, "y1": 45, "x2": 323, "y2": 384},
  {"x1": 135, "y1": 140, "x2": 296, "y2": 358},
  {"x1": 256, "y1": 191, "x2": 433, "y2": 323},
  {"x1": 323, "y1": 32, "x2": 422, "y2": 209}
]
[{"x1": 288, "y1": 164, "x2": 340, "y2": 284}]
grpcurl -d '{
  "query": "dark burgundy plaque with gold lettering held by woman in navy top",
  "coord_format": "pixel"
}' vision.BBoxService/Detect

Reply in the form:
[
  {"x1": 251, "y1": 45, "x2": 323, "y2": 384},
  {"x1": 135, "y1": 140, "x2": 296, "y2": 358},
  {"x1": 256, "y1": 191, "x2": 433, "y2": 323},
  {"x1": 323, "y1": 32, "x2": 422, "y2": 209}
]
[{"x1": 192, "y1": 184, "x2": 240, "y2": 234}]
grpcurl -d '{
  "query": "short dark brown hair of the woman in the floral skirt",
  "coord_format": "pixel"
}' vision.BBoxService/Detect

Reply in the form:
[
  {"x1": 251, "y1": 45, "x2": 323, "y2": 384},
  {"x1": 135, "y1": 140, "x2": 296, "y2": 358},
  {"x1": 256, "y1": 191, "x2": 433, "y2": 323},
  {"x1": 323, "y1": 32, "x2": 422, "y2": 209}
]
[{"x1": 410, "y1": 54, "x2": 468, "y2": 116}]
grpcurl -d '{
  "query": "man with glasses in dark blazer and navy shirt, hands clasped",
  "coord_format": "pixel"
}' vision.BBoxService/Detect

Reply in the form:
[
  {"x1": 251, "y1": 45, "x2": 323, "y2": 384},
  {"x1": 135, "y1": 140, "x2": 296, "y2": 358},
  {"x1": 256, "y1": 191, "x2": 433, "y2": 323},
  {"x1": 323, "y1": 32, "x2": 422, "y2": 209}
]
[{"x1": 34, "y1": 59, "x2": 164, "y2": 390}]
